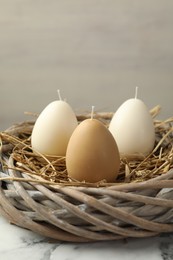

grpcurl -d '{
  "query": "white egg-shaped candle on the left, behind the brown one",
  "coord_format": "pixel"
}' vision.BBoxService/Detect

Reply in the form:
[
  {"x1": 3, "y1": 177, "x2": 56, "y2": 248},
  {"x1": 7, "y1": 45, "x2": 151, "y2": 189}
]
[{"x1": 31, "y1": 91, "x2": 78, "y2": 156}]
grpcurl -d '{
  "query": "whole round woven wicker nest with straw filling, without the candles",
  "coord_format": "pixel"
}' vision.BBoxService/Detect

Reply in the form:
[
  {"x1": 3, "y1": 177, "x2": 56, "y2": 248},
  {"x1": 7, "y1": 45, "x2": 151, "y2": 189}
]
[{"x1": 0, "y1": 107, "x2": 173, "y2": 242}]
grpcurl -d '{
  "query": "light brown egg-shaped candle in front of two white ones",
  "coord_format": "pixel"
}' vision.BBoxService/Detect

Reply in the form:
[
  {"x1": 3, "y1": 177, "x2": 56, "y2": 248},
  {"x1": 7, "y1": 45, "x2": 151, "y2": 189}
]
[{"x1": 66, "y1": 108, "x2": 120, "y2": 183}]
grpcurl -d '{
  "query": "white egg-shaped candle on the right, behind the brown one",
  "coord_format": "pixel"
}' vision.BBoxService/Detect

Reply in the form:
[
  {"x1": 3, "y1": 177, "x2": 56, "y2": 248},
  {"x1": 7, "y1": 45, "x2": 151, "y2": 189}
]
[{"x1": 109, "y1": 89, "x2": 155, "y2": 157}]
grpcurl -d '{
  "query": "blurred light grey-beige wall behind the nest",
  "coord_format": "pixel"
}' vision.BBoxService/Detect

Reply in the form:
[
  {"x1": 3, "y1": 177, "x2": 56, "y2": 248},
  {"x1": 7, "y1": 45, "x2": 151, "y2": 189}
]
[{"x1": 0, "y1": 0, "x2": 173, "y2": 130}]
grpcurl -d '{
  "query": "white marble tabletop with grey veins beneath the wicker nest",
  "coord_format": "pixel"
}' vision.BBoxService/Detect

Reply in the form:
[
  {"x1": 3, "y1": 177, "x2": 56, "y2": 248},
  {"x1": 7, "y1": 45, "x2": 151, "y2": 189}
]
[{"x1": 0, "y1": 217, "x2": 173, "y2": 260}]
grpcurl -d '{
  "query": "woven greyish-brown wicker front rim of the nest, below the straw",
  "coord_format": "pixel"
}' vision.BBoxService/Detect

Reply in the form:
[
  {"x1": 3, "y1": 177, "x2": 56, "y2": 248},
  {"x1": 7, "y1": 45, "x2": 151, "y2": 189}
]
[{"x1": 0, "y1": 112, "x2": 173, "y2": 242}]
